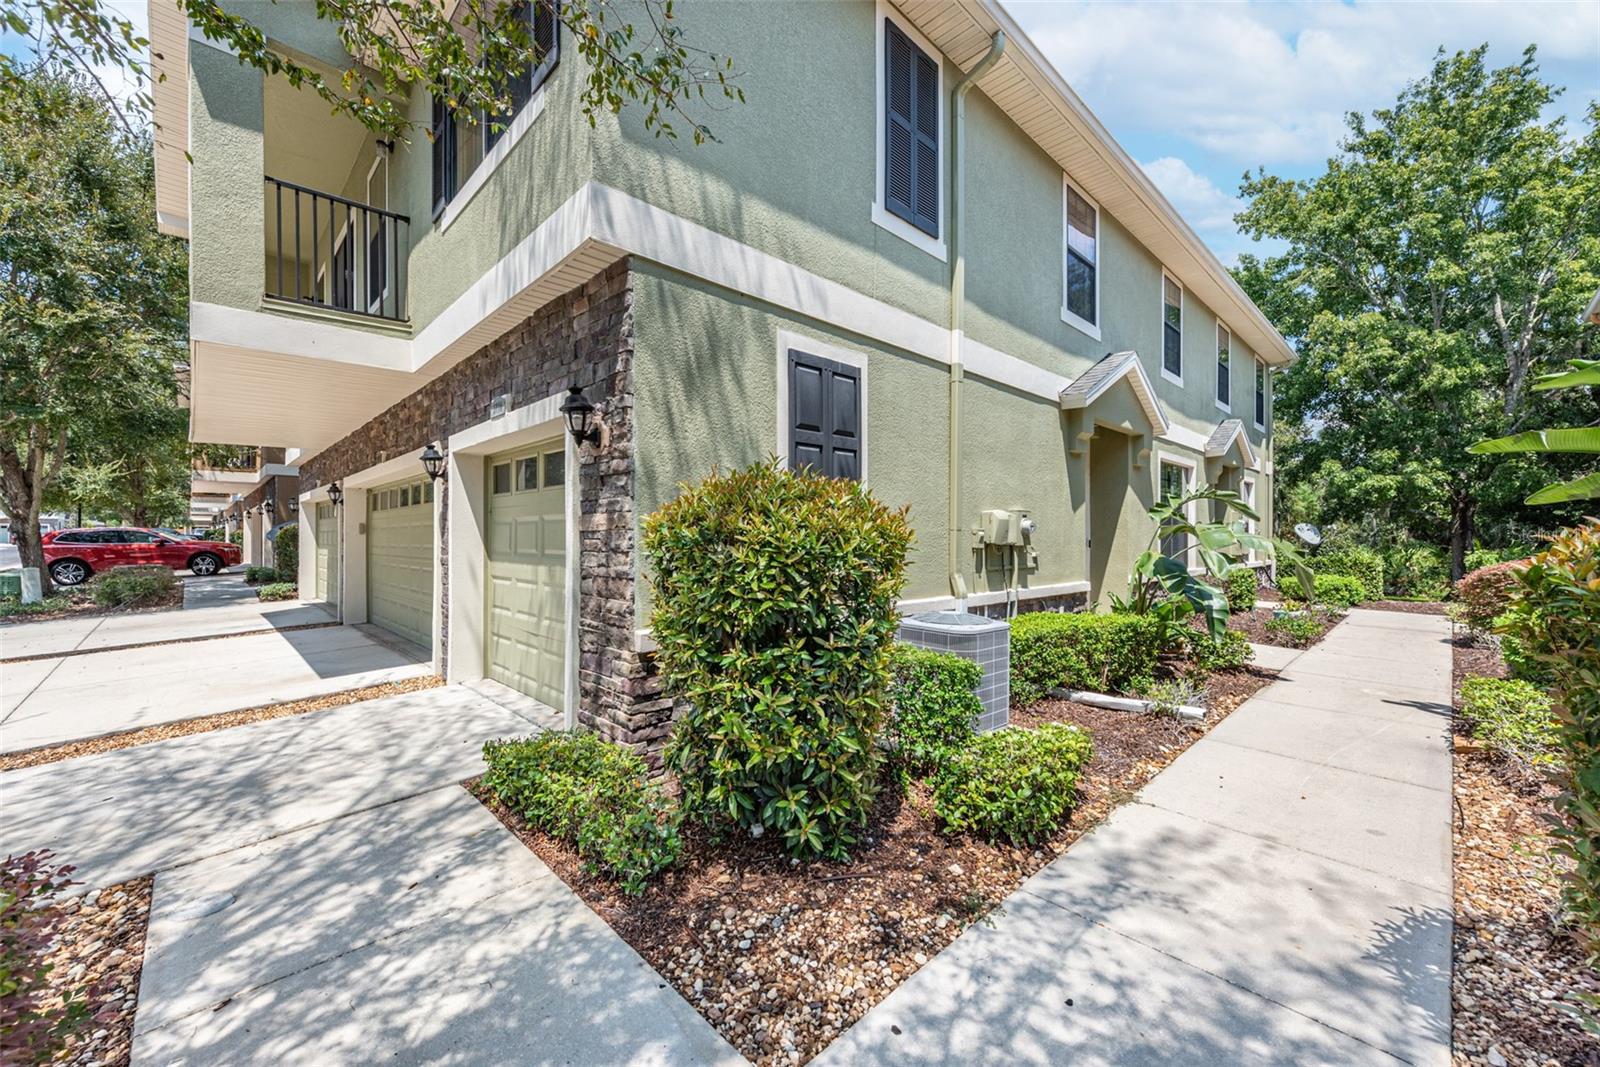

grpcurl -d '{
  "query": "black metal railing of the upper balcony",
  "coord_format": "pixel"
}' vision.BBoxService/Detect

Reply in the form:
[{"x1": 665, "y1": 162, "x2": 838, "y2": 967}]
[{"x1": 264, "y1": 178, "x2": 411, "y2": 322}]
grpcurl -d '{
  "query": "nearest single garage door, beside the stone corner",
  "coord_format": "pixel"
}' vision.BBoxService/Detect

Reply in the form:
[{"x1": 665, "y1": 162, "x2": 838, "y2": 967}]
[{"x1": 483, "y1": 438, "x2": 566, "y2": 709}]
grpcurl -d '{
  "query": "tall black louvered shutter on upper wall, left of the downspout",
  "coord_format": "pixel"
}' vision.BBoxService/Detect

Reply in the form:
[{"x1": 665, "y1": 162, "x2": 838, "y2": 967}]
[{"x1": 883, "y1": 19, "x2": 939, "y2": 237}]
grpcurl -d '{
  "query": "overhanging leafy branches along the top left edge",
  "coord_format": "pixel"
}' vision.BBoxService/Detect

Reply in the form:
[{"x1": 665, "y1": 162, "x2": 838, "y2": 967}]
[{"x1": 0, "y1": 0, "x2": 744, "y2": 144}]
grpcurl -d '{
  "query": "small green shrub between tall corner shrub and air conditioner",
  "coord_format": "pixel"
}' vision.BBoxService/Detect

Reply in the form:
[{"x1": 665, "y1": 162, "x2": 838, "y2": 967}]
[{"x1": 888, "y1": 645, "x2": 984, "y2": 773}]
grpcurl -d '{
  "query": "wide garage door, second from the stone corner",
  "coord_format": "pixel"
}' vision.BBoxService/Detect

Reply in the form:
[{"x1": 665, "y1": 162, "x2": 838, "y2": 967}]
[{"x1": 366, "y1": 478, "x2": 434, "y2": 648}]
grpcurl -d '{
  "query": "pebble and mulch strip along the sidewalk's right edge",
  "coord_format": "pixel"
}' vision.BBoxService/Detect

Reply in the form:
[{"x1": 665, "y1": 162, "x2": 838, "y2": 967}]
[{"x1": 1451, "y1": 630, "x2": 1600, "y2": 1067}]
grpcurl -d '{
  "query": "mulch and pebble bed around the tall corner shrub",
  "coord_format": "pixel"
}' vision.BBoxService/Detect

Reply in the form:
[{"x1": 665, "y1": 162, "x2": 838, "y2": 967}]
[{"x1": 466, "y1": 669, "x2": 1275, "y2": 1067}]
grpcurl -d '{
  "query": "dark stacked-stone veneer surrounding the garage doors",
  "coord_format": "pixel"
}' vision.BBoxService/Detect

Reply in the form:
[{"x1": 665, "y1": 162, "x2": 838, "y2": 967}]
[{"x1": 299, "y1": 261, "x2": 672, "y2": 750}]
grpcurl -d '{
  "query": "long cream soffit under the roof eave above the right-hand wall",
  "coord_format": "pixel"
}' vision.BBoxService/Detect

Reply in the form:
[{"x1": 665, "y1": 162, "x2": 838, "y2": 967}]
[{"x1": 896, "y1": 0, "x2": 1294, "y2": 365}]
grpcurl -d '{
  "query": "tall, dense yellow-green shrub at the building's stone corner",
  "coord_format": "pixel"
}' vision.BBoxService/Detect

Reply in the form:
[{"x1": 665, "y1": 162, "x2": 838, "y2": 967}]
[{"x1": 643, "y1": 461, "x2": 912, "y2": 857}]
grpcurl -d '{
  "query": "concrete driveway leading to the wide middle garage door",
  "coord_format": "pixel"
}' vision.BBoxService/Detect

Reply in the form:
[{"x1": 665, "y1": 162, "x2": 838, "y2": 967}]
[{"x1": 0, "y1": 613, "x2": 434, "y2": 752}]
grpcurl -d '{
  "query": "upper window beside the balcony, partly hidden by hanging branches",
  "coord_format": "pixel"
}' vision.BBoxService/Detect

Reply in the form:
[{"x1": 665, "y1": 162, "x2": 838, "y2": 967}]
[{"x1": 429, "y1": 0, "x2": 562, "y2": 218}]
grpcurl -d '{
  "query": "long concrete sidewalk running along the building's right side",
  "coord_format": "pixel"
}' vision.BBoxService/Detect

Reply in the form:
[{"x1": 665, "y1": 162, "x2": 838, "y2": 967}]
[{"x1": 816, "y1": 611, "x2": 1451, "y2": 1065}]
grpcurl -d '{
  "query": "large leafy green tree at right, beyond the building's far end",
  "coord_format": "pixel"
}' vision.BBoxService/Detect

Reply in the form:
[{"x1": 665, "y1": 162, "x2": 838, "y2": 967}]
[{"x1": 1237, "y1": 48, "x2": 1600, "y2": 577}]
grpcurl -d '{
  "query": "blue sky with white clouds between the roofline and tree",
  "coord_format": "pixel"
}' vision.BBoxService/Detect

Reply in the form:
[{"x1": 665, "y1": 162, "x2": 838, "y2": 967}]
[{"x1": 1003, "y1": 0, "x2": 1600, "y2": 262}]
